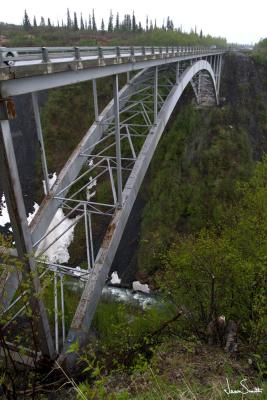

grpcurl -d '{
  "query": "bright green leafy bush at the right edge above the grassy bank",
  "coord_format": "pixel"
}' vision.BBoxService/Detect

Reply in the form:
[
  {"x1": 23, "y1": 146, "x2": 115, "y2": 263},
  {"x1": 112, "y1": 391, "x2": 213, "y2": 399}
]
[{"x1": 159, "y1": 159, "x2": 267, "y2": 346}]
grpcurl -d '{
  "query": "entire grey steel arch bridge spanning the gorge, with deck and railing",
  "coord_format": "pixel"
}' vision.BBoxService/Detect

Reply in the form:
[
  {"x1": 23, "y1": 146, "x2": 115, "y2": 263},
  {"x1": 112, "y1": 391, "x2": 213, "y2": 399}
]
[{"x1": 0, "y1": 47, "x2": 225, "y2": 366}]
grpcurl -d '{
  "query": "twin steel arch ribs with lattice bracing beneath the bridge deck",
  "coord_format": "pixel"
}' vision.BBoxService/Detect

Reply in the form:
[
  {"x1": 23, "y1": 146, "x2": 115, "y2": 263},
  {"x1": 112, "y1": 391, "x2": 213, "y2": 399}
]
[{"x1": 0, "y1": 54, "x2": 224, "y2": 366}]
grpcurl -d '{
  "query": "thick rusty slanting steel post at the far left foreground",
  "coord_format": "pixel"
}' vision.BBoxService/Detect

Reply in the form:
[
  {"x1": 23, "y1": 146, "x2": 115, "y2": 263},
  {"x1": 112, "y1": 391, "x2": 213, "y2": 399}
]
[{"x1": 0, "y1": 120, "x2": 54, "y2": 358}]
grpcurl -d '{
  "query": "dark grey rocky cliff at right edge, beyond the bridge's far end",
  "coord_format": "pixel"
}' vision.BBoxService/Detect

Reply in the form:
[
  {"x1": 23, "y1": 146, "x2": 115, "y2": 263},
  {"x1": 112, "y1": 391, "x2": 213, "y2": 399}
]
[{"x1": 221, "y1": 53, "x2": 267, "y2": 160}]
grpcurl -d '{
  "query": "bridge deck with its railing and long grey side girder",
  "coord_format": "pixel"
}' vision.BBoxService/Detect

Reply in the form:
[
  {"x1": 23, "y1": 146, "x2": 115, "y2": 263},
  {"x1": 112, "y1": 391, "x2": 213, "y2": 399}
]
[{"x1": 0, "y1": 47, "x2": 225, "y2": 97}]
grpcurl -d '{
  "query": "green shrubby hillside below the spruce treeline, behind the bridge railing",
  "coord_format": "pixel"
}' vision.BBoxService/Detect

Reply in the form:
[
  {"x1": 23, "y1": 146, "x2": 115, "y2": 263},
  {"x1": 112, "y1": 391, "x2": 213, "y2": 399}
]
[{"x1": 0, "y1": 22, "x2": 227, "y2": 47}]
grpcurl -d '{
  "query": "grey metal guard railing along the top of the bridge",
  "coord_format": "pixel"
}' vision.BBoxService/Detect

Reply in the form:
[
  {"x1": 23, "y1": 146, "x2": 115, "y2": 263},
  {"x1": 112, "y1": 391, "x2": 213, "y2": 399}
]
[{"x1": 0, "y1": 46, "x2": 225, "y2": 67}]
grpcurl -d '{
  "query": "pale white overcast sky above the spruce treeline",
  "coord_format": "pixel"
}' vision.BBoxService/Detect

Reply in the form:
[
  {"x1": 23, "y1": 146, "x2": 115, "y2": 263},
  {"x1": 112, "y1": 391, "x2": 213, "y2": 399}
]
[{"x1": 0, "y1": 0, "x2": 267, "y2": 43}]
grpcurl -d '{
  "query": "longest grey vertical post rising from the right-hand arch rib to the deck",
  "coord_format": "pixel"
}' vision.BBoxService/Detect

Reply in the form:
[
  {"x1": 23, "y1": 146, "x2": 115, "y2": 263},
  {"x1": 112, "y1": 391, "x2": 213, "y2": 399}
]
[{"x1": 113, "y1": 74, "x2": 122, "y2": 208}]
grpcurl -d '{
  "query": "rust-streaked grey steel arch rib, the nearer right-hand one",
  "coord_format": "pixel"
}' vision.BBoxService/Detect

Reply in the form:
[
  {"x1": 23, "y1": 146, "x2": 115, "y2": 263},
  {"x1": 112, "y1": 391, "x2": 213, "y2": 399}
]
[{"x1": 55, "y1": 60, "x2": 221, "y2": 365}]
